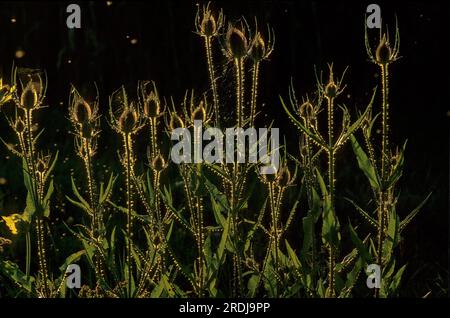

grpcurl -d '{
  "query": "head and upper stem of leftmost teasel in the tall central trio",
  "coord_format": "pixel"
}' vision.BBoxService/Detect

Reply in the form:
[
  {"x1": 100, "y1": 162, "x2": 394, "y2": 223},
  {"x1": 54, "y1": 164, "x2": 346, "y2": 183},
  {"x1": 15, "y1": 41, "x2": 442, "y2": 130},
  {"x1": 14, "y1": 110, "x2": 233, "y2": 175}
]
[{"x1": 195, "y1": 2, "x2": 225, "y2": 127}]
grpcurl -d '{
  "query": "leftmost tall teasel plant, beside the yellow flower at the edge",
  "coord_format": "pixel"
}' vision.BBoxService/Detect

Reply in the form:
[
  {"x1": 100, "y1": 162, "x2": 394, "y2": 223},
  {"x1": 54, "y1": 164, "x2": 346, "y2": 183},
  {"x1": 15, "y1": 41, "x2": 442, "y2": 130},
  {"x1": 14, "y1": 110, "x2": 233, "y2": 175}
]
[{"x1": 2, "y1": 67, "x2": 60, "y2": 297}]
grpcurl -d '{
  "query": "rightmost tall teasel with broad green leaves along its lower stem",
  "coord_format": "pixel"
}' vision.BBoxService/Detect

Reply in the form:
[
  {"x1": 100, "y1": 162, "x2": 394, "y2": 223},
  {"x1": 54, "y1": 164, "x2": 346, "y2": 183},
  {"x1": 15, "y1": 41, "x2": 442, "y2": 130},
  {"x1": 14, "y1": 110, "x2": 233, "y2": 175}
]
[{"x1": 346, "y1": 21, "x2": 431, "y2": 297}]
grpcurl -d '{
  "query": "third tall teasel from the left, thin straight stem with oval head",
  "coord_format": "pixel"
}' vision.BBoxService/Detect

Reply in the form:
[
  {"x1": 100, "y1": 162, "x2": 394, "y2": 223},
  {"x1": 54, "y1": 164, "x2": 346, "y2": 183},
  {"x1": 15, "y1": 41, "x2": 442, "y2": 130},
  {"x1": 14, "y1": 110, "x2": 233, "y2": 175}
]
[{"x1": 109, "y1": 86, "x2": 145, "y2": 297}]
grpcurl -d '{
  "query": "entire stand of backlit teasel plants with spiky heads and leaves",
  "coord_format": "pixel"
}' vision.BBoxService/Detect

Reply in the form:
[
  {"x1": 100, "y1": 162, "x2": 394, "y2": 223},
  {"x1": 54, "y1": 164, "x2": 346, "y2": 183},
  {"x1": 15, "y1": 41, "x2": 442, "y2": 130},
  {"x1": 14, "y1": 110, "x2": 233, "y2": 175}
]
[{"x1": 0, "y1": 4, "x2": 426, "y2": 297}]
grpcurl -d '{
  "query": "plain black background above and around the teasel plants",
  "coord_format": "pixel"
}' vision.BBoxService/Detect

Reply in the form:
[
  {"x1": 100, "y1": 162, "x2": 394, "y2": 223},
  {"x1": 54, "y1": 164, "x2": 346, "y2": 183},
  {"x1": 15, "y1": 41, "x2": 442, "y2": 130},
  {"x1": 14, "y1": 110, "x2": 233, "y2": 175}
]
[{"x1": 0, "y1": 1, "x2": 450, "y2": 296}]
